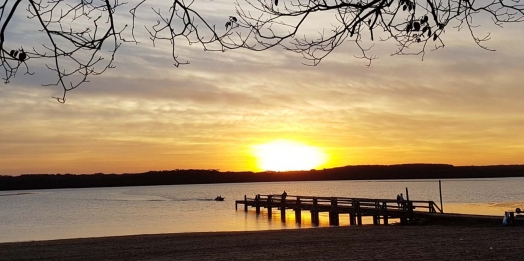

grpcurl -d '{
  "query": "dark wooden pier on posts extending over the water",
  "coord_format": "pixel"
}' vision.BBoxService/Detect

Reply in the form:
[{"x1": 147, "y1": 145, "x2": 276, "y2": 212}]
[{"x1": 235, "y1": 194, "x2": 442, "y2": 226}]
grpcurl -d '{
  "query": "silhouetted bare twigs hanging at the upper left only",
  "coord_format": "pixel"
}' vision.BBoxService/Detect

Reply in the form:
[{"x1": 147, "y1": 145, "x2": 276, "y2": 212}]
[{"x1": 0, "y1": 0, "x2": 242, "y2": 103}]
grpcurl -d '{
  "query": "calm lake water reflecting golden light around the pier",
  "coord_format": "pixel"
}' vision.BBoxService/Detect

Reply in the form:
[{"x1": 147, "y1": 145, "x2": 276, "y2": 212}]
[{"x1": 0, "y1": 178, "x2": 524, "y2": 242}]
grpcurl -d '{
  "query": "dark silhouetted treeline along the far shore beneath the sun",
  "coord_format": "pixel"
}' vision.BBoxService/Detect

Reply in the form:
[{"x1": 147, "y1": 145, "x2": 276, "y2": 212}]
[{"x1": 0, "y1": 164, "x2": 524, "y2": 190}]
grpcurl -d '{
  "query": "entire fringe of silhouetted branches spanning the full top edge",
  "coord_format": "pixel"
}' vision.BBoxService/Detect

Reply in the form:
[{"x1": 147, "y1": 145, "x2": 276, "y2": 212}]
[{"x1": 0, "y1": 0, "x2": 524, "y2": 102}]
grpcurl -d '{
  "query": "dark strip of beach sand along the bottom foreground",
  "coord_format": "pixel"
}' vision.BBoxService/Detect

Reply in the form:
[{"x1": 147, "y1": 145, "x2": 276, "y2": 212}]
[{"x1": 0, "y1": 225, "x2": 524, "y2": 261}]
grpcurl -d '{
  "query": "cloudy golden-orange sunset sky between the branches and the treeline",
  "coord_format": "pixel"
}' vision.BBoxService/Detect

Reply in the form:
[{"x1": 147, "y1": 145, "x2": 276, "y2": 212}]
[{"x1": 0, "y1": 1, "x2": 524, "y2": 175}]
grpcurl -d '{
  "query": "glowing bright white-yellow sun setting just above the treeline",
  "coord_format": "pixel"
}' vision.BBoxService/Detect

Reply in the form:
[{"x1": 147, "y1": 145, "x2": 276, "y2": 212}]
[{"x1": 253, "y1": 140, "x2": 327, "y2": 171}]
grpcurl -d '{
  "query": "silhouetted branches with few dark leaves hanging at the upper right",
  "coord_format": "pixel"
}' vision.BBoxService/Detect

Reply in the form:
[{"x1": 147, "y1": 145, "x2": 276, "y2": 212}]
[{"x1": 233, "y1": 0, "x2": 524, "y2": 66}]
